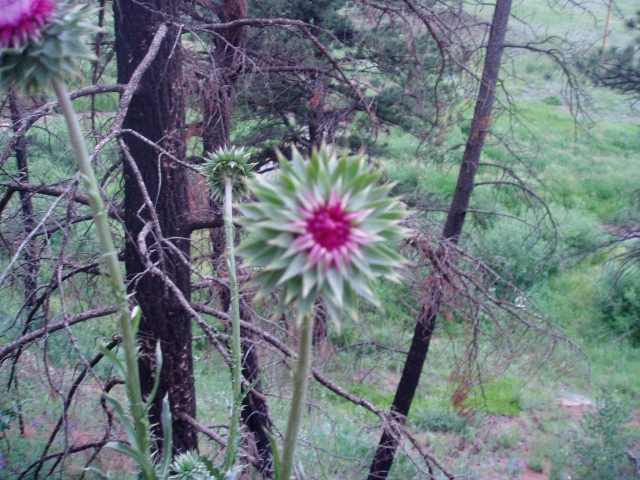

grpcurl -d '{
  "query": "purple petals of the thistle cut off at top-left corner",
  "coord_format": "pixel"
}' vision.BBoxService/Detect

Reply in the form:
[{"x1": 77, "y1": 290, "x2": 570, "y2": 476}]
[{"x1": 0, "y1": 0, "x2": 54, "y2": 49}]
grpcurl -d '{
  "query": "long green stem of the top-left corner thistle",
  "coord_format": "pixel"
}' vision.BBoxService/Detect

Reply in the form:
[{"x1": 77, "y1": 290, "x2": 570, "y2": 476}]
[{"x1": 51, "y1": 78, "x2": 151, "y2": 462}]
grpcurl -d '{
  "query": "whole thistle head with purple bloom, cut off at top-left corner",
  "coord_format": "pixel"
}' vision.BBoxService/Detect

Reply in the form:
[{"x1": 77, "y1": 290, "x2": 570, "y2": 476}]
[{"x1": 0, "y1": 0, "x2": 99, "y2": 95}]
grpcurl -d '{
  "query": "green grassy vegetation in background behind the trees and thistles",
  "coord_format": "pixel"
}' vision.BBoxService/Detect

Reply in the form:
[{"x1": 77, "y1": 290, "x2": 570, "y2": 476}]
[{"x1": 0, "y1": 0, "x2": 640, "y2": 480}]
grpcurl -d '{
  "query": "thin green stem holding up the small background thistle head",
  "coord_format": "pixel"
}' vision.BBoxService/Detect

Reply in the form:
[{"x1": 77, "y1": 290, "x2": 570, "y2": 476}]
[{"x1": 224, "y1": 178, "x2": 242, "y2": 471}]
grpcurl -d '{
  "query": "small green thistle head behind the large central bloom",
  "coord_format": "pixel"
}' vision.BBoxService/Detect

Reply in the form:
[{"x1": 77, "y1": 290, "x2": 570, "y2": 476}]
[{"x1": 200, "y1": 147, "x2": 254, "y2": 202}]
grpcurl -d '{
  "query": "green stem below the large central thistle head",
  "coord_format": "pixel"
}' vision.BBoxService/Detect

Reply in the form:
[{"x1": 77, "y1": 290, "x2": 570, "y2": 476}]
[{"x1": 277, "y1": 313, "x2": 313, "y2": 480}]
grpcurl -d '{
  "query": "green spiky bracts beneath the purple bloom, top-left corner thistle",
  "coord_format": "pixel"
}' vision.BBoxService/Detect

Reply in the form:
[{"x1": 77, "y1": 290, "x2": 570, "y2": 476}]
[{"x1": 0, "y1": 1, "x2": 100, "y2": 95}]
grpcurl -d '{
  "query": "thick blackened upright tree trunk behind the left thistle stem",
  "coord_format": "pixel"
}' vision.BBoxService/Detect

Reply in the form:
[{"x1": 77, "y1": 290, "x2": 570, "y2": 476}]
[{"x1": 113, "y1": 0, "x2": 198, "y2": 452}]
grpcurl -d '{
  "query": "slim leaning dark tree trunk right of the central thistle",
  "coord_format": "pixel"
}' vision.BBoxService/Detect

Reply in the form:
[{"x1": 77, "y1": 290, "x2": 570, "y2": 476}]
[{"x1": 368, "y1": 0, "x2": 511, "y2": 480}]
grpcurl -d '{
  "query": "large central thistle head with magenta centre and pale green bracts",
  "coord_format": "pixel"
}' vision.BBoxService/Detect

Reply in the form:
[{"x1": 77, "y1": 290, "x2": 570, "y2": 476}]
[{"x1": 237, "y1": 146, "x2": 406, "y2": 325}]
